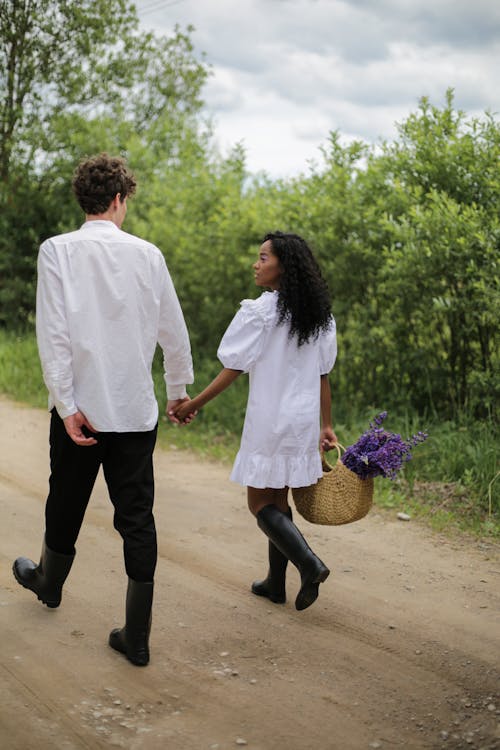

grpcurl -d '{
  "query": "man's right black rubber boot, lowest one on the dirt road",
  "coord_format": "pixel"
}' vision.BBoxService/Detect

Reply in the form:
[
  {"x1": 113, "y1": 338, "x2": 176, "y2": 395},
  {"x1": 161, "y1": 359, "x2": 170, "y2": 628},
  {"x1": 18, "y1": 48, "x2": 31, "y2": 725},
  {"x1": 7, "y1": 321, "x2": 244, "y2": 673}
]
[{"x1": 109, "y1": 578, "x2": 154, "y2": 667}]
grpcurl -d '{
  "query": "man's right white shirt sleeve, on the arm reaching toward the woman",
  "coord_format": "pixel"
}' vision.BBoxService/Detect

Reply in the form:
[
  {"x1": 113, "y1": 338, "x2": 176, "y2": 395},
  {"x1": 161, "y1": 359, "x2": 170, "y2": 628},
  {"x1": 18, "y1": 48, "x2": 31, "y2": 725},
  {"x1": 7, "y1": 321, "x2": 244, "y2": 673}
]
[{"x1": 158, "y1": 256, "x2": 194, "y2": 401}]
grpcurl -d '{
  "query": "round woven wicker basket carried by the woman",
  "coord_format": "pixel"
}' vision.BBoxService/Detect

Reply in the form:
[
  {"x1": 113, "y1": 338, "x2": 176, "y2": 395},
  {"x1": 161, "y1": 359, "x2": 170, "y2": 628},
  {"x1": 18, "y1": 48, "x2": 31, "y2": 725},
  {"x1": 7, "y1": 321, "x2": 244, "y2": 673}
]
[{"x1": 292, "y1": 444, "x2": 373, "y2": 526}]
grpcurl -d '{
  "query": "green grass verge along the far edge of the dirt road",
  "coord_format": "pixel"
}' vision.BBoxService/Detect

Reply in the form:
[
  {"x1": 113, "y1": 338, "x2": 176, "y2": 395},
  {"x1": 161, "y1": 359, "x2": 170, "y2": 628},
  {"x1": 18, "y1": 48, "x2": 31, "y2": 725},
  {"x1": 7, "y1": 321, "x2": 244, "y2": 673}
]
[{"x1": 0, "y1": 330, "x2": 500, "y2": 535}]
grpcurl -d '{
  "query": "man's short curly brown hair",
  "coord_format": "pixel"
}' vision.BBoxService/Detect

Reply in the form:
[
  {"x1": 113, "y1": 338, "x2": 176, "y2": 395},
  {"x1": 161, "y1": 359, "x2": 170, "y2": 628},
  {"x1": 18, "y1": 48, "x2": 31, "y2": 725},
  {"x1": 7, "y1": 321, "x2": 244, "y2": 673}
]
[{"x1": 73, "y1": 153, "x2": 136, "y2": 215}]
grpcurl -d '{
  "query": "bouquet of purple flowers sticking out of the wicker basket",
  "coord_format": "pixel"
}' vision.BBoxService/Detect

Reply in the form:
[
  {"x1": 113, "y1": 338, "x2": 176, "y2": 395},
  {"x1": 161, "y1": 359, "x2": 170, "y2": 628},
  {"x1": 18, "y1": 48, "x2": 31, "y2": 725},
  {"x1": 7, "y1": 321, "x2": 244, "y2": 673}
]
[{"x1": 341, "y1": 411, "x2": 427, "y2": 479}]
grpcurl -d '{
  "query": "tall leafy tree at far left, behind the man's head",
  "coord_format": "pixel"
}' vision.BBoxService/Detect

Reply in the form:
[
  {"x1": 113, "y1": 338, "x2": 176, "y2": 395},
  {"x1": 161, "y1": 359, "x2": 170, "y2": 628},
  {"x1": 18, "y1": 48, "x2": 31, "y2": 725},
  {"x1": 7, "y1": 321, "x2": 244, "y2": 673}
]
[{"x1": 0, "y1": 0, "x2": 208, "y2": 326}]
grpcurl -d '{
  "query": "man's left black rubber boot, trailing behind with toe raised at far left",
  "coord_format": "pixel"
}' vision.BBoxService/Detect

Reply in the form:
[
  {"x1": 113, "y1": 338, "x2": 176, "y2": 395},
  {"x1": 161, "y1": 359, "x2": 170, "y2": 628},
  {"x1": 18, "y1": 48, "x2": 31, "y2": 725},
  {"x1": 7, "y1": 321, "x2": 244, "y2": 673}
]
[{"x1": 12, "y1": 538, "x2": 75, "y2": 609}]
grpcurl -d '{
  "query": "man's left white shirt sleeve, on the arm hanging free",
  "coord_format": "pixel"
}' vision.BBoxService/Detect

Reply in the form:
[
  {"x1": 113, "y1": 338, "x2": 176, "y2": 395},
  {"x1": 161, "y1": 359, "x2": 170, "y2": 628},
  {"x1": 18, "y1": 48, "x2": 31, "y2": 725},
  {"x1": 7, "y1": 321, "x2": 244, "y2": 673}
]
[{"x1": 36, "y1": 240, "x2": 78, "y2": 419}]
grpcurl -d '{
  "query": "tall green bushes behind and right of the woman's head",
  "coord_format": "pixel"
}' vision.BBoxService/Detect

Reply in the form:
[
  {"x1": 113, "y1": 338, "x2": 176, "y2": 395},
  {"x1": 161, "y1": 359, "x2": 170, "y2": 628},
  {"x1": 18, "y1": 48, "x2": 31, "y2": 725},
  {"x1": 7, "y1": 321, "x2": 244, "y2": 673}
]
[{"x1": 239, "y1": 92, "x2": 500, "y2": 418}]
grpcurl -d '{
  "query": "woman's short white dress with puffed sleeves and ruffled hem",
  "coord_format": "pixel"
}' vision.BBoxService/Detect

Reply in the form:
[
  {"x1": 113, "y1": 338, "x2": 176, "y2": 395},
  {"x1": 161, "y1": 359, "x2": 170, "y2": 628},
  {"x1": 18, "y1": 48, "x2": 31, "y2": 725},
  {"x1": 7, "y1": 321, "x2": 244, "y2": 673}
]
[{"x1": 217, "y1": 292, "x2": 337, "y2": 489}]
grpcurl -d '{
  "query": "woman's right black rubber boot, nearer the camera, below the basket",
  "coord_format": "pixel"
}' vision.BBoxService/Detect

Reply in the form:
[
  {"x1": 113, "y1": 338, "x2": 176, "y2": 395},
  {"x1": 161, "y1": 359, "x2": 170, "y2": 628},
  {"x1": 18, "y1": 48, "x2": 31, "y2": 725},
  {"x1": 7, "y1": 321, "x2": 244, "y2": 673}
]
[{"x1": 257, "y1": 504, "x2": 330, "y2": 610}]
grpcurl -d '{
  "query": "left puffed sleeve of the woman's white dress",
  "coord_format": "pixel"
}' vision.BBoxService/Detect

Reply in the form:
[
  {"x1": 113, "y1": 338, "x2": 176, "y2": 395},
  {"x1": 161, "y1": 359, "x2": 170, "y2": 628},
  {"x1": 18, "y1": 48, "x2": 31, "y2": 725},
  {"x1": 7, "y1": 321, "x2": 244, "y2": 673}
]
[{"x1": 217, "y1": 300, "x2": 268, "y2": 372}]
